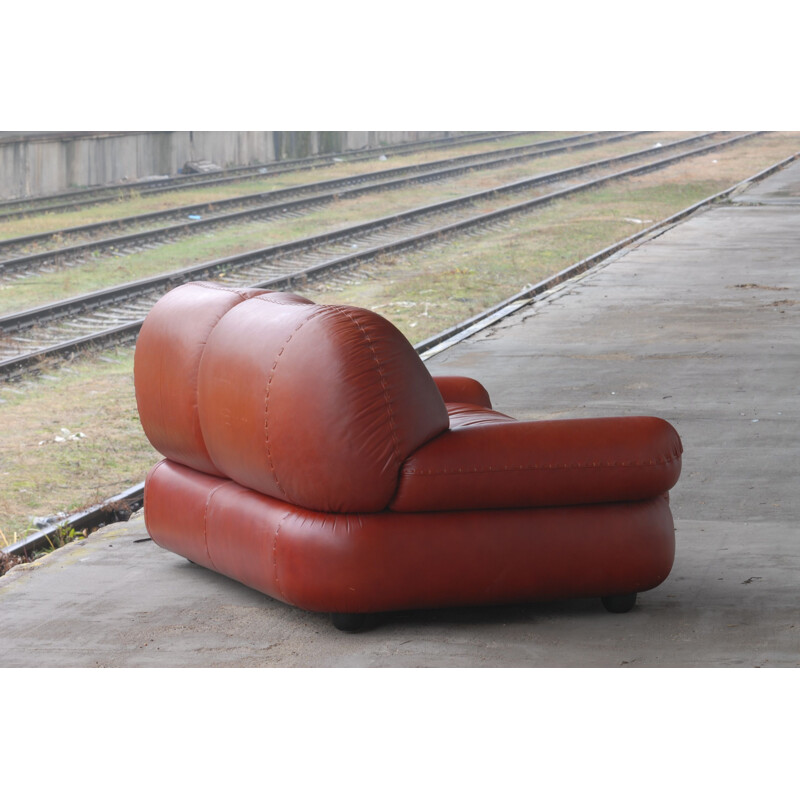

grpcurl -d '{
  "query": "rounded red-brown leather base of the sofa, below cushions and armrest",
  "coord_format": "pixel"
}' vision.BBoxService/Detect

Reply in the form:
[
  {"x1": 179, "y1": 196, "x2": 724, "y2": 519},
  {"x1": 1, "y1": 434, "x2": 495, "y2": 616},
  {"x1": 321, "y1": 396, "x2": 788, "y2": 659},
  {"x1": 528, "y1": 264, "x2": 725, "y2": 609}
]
[{"x1": 145, "y1": 461, "x2": 675, "y2": 612}]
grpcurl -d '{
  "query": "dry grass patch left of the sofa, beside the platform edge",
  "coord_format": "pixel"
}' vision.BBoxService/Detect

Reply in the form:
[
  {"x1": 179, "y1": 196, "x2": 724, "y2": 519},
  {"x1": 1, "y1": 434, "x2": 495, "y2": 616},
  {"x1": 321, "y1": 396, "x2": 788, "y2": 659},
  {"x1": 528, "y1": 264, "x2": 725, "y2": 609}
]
[{"x1": 0, "y1": 347, "x2": 159, "y2": 542}]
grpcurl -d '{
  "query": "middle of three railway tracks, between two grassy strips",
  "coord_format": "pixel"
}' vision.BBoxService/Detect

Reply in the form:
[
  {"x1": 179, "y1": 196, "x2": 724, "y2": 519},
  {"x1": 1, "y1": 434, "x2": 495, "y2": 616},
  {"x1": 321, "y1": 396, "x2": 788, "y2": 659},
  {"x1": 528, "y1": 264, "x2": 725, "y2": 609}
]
[{"x1": 0, "y1": 131, "x2": 642, "y2": 266}]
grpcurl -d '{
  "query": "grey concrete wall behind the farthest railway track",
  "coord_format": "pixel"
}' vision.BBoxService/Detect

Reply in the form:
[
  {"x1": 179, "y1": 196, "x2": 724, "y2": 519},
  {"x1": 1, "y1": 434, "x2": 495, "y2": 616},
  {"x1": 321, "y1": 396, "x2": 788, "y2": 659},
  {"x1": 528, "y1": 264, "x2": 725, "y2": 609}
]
[{"x1": 0, "y1": 131, "x2": 450, "y2": 199}]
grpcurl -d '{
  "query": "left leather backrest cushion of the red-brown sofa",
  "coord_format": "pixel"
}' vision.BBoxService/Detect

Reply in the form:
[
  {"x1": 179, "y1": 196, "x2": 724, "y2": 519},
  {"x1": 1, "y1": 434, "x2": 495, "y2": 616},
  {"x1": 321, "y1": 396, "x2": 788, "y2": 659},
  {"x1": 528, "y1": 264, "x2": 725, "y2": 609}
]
[{"x1": 134, "y1": 283, "x2": 278, "y2": 475}]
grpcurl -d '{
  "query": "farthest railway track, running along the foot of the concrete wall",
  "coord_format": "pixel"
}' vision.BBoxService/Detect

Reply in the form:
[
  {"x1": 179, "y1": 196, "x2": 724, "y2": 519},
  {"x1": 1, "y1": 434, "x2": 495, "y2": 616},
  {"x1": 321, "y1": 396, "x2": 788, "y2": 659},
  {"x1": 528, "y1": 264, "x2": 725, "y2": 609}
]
[{"x1": 0, "y1": 131, "x2": 530, "y2": 222}]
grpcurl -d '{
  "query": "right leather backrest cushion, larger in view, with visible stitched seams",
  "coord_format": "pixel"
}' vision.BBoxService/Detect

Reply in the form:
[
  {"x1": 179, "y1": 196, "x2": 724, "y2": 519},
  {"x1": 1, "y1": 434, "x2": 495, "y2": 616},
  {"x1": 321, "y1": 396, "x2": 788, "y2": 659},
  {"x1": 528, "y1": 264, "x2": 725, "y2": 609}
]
[{"x1": 198, "y1": 294, "x2": 448, "y2": 512}]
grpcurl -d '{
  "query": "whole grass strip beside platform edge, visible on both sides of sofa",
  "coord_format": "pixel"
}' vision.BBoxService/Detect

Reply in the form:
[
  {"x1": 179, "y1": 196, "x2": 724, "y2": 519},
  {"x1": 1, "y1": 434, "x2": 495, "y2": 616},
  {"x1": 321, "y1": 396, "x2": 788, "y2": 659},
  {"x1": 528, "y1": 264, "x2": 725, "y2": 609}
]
[{"x1": 0, "y1": 133, "x2": 800, "y2": 543}]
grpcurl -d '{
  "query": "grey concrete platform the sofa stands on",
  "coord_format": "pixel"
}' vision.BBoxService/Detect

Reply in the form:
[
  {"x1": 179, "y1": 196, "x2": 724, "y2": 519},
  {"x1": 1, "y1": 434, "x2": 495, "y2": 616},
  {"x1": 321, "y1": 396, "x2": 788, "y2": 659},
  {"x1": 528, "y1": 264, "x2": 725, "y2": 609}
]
[{"x1": 0, "y1": 162, "x2": 800, "y2": 667}]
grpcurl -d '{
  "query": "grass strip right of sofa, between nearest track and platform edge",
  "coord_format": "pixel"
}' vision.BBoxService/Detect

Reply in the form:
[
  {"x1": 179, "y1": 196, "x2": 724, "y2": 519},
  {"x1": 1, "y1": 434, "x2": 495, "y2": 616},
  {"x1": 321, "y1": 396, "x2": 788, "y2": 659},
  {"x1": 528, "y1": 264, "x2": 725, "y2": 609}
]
[{"x1": 298, "y1": 134, "x2": 800, "y2": 342}]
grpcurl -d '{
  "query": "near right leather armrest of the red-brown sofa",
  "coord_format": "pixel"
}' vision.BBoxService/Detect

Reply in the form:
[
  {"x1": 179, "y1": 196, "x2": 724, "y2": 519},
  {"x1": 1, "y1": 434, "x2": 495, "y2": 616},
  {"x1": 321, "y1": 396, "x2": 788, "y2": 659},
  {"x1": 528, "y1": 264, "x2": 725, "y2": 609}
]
[{"x1": 390, "y1": 417, "x2": 682, "y2": 511}]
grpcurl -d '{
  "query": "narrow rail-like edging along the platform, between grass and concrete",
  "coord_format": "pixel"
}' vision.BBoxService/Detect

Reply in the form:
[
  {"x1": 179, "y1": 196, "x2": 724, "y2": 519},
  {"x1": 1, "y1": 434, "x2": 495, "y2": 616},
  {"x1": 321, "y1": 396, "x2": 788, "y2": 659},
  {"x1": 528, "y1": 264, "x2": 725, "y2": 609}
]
[{"x1": 2, "y1": 152, "x2": 800, "y2": 555}]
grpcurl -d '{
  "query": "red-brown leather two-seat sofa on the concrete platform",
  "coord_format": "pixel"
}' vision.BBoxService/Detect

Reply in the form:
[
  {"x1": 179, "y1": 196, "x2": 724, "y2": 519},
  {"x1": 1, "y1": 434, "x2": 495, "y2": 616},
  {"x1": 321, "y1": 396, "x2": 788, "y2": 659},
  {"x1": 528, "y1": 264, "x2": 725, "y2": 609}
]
[{"x1": 135, "y1": 283, "x2": 682, "y2": 630}]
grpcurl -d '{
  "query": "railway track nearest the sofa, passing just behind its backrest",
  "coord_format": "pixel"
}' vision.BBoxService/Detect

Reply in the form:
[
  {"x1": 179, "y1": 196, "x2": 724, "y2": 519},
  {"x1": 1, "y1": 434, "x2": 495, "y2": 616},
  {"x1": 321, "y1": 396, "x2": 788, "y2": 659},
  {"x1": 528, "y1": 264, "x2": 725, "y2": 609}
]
[{"x1": 0, "y1": 132, "x2": 758, "y2": 378}]
